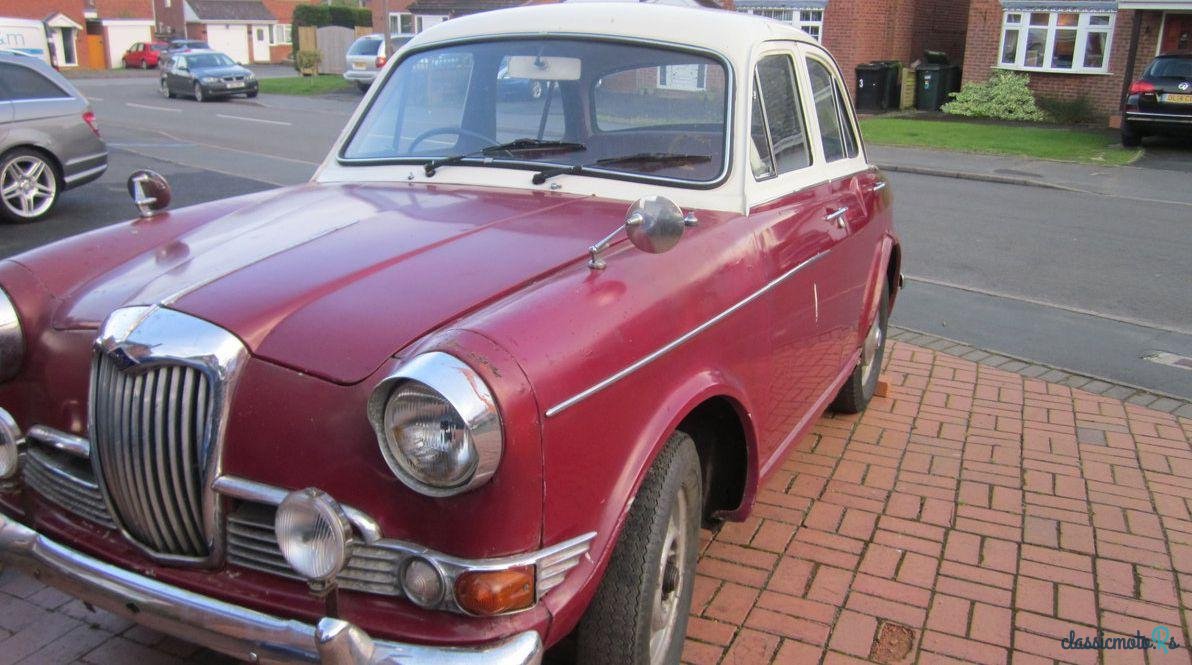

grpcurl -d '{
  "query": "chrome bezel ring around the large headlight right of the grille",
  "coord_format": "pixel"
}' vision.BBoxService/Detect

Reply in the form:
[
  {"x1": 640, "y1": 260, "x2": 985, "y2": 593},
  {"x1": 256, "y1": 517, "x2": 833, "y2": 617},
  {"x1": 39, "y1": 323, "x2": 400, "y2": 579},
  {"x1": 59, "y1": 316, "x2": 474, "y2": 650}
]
[{"x1": 368, "y1": 352, "x2": 504, "y2": 497}]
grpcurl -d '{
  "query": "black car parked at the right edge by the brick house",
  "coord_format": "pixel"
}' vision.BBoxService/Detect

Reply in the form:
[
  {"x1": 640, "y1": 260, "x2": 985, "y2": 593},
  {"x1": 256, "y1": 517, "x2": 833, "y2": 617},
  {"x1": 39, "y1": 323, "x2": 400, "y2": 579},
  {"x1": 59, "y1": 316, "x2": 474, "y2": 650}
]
[{"x1": 1122, "y1": 52, "x2": 1192, "y2": 147}]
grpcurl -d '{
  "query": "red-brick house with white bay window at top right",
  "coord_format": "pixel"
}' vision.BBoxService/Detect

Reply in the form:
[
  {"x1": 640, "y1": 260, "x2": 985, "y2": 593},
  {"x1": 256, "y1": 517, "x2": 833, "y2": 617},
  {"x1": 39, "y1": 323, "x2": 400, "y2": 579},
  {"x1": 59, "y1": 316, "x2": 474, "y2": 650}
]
[{"x1": 964, "y1": 0, "x2": 1192, "y2": 124}]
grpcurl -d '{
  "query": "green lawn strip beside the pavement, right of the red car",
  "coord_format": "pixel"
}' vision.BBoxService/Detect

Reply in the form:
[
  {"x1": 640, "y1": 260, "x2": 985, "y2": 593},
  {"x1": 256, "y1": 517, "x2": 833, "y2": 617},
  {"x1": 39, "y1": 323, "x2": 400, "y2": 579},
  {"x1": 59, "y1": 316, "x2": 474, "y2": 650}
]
[{"x1": 861, "y1": 118, "x2": 1141, "y2": 164}]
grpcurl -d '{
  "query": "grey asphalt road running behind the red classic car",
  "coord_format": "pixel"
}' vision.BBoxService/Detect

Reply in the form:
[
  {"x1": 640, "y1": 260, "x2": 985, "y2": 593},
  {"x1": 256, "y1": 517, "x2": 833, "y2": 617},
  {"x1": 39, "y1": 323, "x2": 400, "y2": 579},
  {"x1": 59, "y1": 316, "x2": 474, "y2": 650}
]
[{"x1": 7, "y1": 79, "x2": 1192, "y2": 399}]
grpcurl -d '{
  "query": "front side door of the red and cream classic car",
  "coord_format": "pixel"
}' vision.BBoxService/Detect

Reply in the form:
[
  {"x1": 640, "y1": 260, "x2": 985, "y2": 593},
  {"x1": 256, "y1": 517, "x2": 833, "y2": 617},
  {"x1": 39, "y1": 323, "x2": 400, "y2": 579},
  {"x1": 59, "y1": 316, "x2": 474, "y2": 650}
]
[{"x1": 745, "y1": 48, "x2": 839, "y2": 464}]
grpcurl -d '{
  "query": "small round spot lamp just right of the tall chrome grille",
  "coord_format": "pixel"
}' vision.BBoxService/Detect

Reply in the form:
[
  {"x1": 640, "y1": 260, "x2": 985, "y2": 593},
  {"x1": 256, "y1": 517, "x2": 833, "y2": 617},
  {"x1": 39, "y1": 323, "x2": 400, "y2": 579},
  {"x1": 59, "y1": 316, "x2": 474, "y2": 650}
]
[{"x1": 274, "y1": 487, "x2": 352, "y2": 582}]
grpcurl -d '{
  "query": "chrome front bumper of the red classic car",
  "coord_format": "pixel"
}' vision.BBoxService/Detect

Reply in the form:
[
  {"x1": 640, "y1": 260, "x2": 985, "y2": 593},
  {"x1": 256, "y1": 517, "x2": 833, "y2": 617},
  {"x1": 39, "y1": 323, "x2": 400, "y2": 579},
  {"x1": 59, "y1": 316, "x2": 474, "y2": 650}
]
[{"x1": 0, "y1": 514, "x2": 542, "y2": 665}]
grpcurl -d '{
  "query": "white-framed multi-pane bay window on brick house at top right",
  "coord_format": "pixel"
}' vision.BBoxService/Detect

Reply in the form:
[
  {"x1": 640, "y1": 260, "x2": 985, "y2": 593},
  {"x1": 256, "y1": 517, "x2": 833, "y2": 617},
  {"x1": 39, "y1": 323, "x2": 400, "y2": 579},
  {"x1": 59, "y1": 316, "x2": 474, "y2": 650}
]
[{"x1": 994, "y1": 10, "x2": 1117, "y2": 74}]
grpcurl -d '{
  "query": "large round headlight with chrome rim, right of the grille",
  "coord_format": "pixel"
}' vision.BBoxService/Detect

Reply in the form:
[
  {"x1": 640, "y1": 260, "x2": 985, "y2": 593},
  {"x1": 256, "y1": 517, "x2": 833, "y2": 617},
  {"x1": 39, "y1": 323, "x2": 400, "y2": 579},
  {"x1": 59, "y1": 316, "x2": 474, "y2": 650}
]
[{"x1": 368, "y1": 352, "x2": 503, "y2": 497}]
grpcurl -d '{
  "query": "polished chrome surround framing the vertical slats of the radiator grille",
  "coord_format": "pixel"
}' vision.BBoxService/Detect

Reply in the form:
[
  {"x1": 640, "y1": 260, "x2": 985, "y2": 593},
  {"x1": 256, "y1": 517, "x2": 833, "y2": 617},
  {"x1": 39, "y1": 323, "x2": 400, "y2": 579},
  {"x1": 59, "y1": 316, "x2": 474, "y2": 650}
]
[{"x1": 87, "y1": 305, "x2": 248, "y2": 567}]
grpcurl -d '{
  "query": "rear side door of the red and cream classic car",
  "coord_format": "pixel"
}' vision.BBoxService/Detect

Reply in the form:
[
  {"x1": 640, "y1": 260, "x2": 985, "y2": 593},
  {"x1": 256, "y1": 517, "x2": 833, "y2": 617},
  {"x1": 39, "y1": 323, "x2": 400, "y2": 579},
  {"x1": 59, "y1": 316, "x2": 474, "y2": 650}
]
[{"x1": 800, "y1": 44, "x2": 876, "y2": 362}]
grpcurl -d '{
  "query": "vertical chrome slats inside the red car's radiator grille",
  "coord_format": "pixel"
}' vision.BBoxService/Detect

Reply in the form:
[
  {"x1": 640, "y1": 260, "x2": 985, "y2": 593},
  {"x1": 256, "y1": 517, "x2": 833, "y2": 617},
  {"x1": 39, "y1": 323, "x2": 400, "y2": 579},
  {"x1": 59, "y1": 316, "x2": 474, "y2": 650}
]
[{"x1": 91, "y1": 353, "x2": 213, "y2": 558}]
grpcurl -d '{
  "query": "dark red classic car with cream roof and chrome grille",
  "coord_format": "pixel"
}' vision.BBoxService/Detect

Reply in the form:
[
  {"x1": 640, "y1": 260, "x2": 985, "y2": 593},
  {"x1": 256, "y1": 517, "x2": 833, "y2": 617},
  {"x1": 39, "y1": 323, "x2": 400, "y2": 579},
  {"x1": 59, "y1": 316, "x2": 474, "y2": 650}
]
[{"x1": 0, "y1": 2, "x2": 901, "y2": 664}]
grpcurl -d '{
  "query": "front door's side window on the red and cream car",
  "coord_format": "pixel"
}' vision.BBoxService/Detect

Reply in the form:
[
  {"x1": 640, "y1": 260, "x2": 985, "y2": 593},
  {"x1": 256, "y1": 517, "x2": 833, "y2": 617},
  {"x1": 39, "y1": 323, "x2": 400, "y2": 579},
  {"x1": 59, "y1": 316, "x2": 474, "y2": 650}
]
[{"x1": 750, "y1": 55, "x2": 812, "y2": 178}]
